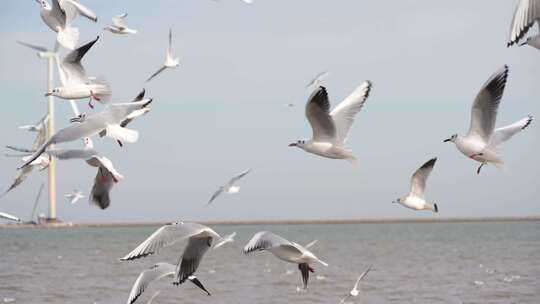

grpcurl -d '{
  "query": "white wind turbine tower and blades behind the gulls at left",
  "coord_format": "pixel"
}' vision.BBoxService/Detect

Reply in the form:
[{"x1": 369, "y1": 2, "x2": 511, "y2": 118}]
[{"x1": 17, "y1": 40, "x2": 80, "y2": 223}]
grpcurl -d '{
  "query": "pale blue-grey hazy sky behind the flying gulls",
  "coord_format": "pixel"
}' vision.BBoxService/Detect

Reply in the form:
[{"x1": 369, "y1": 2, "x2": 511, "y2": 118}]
[{"x1": 0, "y1": 0, "x2": 540, "y2": 222}]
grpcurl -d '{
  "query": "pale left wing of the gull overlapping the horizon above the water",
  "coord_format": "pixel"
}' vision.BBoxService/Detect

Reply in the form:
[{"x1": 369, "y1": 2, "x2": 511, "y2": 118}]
[{"x1": 120, "y1": 222, "x2": 215, "y2": 261}]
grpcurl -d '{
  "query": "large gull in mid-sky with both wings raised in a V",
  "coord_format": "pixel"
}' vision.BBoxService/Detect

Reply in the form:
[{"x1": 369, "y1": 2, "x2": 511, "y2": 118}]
[{"x1": 289, "y1": 81, "x2": 371, "y2": 164}]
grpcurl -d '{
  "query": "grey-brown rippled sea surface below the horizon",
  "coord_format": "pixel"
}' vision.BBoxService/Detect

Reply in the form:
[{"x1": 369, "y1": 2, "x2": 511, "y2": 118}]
[{"x1": 0, "y1": 221, "x2": 540, "y2": 304}]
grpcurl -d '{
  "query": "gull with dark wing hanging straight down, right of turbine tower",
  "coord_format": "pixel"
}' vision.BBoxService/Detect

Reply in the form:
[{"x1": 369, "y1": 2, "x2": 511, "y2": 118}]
[{"x1": 46, "y1": 138, "x2": 124, "y2": 209}]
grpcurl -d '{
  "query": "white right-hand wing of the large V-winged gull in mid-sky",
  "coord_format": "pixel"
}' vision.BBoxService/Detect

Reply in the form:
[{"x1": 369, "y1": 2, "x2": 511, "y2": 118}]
[{"x1": 330, "y1": 81, "x2": 371, "y2": 143}]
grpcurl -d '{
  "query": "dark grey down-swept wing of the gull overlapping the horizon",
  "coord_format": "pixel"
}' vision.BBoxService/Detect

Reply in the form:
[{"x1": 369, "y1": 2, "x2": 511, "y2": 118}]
[{"x1": 174, "y1": 235, "x2": 213, "y2": 285}]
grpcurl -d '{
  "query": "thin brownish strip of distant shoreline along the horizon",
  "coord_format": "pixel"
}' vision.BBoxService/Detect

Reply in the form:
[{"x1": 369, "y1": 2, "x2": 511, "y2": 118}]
[{"x1": 0, "y1": 215, "x2": 540, "y2": 229}]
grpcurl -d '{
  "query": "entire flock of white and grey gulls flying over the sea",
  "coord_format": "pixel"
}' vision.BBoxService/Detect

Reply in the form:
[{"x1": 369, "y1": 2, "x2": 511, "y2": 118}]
[{"x1": 0, "y1": 0, "x2": 540, "y2": 304}]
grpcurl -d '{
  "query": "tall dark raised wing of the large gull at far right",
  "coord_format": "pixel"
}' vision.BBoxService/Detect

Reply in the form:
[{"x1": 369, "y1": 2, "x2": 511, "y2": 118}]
[{"x1": 467, "y1": 65, "x2": 508, "y2": 144}]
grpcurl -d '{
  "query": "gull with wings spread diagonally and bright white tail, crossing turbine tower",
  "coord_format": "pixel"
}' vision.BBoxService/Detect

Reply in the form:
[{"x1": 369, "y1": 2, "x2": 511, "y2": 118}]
[{"x1": 20, "y1": 99, "x2": 152, "y2": 168}]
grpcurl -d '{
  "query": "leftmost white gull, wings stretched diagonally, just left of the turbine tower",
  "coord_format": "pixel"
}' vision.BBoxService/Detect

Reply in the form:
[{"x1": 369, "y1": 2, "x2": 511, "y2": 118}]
[{"x1": 0, "y1": 116, "x2": 49, "y2": 198}]
